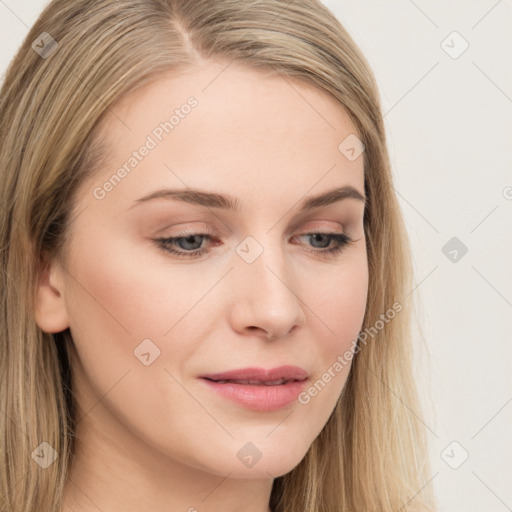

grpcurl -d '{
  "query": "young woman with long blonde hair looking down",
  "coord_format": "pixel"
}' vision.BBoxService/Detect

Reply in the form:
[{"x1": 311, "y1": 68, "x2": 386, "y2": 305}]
[{"x1": 0, "y1": 0, "x2": 432, "y2": 512}]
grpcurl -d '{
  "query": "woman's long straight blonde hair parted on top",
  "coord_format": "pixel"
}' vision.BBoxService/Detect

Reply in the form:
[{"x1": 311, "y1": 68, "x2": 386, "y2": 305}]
[{"x1": 0, "y1": 0, "x2": 433, "y2": 512}]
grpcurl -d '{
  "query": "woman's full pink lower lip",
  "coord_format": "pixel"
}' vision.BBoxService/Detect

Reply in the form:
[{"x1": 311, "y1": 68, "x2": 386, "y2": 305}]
[{"x1": 201, "y1": 379, "x2": 307, "y2": 412}]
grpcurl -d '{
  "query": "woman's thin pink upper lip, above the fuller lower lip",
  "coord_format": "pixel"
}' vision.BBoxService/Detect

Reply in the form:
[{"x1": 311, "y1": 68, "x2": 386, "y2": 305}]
[{"x1": 202, "y1": 365, "x2": 308, "y2": 386}]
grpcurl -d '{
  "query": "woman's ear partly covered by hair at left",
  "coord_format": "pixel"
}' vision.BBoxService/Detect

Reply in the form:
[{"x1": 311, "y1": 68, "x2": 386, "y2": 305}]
[{"x1": 34, "y1": 253, "x2": 69, "y2": 333}]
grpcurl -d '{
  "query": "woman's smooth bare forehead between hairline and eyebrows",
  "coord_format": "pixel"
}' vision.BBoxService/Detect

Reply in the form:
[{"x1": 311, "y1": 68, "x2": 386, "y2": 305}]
[{"x1": 79, "y1": 62, "x2": 364, "y2": 214}]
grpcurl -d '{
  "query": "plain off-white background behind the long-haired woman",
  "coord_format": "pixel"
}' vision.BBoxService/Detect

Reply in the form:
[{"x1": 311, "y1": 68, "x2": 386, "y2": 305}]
[{"x1": 0, "y1": 0, "x2": 512, "y2": 512}]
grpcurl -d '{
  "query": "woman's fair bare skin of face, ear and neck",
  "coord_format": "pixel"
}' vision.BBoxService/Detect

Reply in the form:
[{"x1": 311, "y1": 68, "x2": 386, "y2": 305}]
[{"x1": 35, "y1": 61, "x2": 368, "y2": 512}]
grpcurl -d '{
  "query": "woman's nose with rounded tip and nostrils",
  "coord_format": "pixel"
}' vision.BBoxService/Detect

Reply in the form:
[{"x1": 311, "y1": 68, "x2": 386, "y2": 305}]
[{"x1": 230, "y1": 242, "x2": 305, "y2": 340}]
